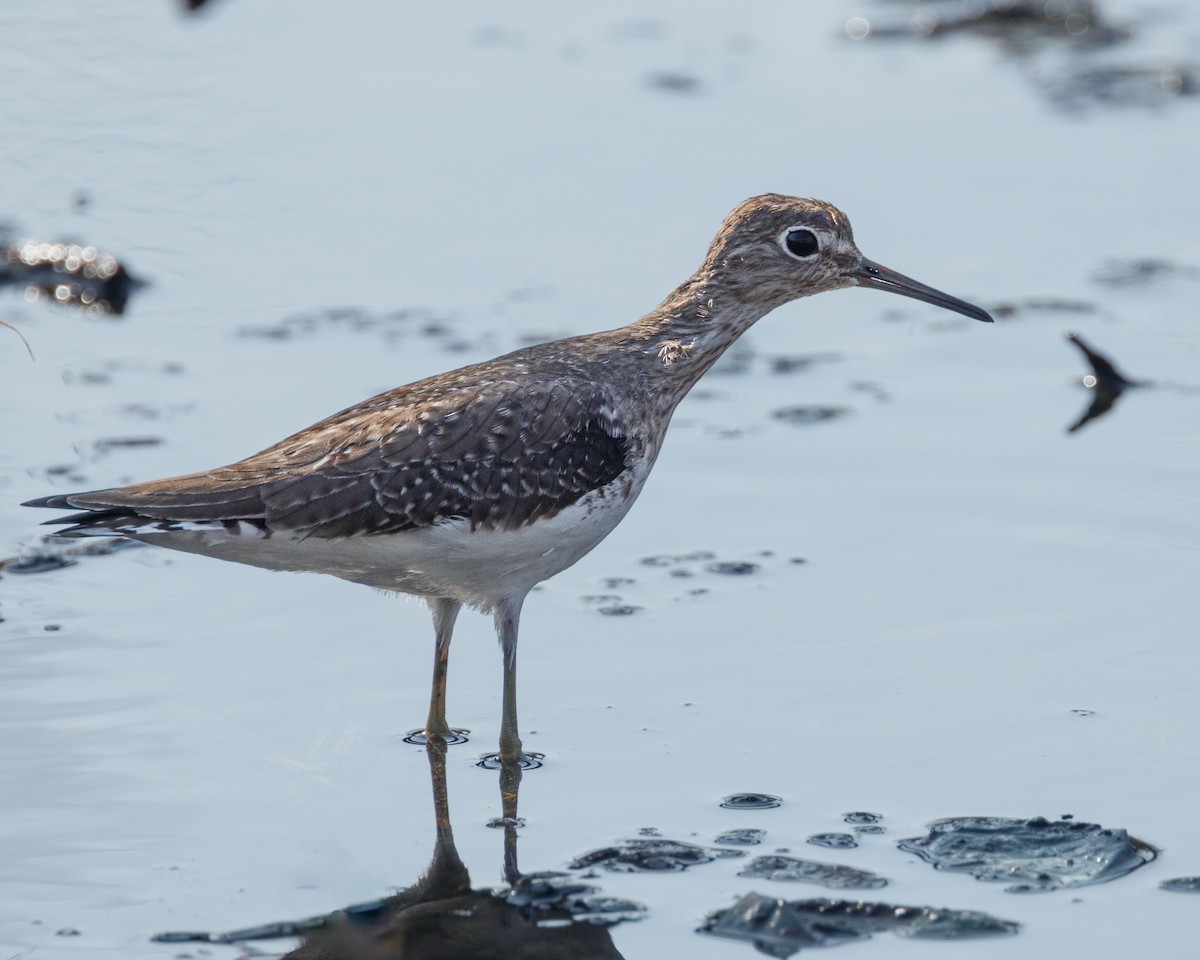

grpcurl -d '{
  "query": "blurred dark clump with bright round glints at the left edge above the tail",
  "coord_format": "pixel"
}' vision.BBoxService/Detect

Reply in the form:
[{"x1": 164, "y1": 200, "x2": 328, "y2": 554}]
[{"x1": 0, "y1": 240, "x2": 144, "y2": 317}]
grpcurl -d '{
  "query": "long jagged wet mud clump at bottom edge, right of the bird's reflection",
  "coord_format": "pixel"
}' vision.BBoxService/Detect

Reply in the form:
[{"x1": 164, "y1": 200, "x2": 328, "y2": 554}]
[{"x1": 700, "y1": 893, "x2": 1020, "y2": 958}]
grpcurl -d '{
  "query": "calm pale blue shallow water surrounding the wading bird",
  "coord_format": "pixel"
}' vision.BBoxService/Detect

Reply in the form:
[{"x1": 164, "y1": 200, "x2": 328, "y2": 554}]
[{"x1": 0, "y1": 0, "x2": 1200, "y2": 960}]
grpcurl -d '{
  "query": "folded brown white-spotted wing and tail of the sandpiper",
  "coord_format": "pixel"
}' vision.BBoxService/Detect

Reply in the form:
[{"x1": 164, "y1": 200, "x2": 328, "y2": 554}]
[{"x1": 29, "y1": 377, "x2": 630, "y2": 538}]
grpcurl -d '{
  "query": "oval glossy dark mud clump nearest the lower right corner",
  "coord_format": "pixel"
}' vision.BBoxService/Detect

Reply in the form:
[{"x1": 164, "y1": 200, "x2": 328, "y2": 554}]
[{"x1": 898, "y1": 817, "x2": 1158, "y2": 893}]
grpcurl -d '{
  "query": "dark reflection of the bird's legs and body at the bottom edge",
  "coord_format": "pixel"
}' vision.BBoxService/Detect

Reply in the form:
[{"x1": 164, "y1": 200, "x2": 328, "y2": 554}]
[{"x1": 155, "y1": 736, "x2": 644, "y2": 960}]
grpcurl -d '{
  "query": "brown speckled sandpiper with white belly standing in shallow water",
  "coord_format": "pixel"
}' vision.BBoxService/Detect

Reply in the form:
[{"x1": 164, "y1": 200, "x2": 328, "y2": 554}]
[{"x1": 26, "y1": 194, "x2": 991, "y2": 763}]
